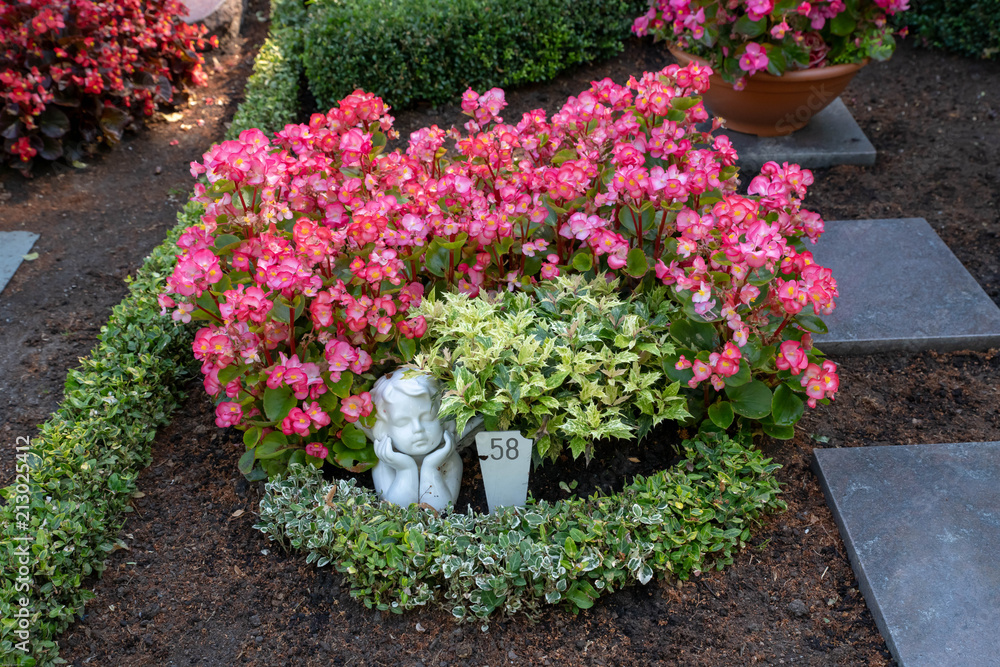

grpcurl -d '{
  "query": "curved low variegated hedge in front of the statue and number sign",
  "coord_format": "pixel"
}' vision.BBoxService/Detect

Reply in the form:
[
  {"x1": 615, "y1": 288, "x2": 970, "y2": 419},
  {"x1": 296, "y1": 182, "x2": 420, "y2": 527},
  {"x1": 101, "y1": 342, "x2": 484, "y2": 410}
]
[{"x1": 255, "y1": 438, "x2": 785, "y2": 621}]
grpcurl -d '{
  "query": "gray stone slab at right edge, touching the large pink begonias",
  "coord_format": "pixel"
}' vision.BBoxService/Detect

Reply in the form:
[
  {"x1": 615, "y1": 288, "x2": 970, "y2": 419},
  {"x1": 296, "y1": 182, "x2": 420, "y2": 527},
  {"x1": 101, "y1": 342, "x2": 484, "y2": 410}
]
[{"x1": 807, "y1": 218, "x2": 1000, "y2": 354}]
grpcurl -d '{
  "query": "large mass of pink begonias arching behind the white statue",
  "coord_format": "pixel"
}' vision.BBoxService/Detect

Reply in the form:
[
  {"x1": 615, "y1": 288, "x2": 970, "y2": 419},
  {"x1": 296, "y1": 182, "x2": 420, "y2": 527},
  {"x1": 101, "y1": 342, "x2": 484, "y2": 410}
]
[{"x1": 161, "y1": 63, "x2": 837, "y2": 476}]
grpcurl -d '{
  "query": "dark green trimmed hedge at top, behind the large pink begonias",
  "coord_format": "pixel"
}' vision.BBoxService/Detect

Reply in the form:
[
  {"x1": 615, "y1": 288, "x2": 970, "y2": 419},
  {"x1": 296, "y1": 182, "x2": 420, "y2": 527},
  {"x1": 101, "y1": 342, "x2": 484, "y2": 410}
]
[{"x1": 304, "y1": 0, "x2": 647, "y2": 109}]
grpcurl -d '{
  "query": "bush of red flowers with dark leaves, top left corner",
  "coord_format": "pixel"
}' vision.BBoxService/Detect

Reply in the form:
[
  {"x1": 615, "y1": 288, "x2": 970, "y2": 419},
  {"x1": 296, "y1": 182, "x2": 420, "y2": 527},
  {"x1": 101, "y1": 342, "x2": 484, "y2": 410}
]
[{"x1": 0, "y1": 0, "x2": 208, "y2": 173}]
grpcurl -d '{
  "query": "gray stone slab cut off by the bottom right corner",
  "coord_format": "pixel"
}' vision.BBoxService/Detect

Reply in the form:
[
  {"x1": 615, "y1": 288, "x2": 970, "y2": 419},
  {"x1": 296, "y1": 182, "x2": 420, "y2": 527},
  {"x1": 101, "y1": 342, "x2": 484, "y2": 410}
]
[{"x1": 814, "y1": 442, "x2": 1000, "y2": 667}]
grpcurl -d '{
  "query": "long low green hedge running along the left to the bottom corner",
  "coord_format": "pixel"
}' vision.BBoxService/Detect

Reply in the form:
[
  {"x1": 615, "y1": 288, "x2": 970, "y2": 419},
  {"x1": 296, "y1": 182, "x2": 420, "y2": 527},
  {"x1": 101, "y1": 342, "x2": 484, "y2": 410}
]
[{"x1": 0, "y1": 204, "x2": 200, "y2": 665}]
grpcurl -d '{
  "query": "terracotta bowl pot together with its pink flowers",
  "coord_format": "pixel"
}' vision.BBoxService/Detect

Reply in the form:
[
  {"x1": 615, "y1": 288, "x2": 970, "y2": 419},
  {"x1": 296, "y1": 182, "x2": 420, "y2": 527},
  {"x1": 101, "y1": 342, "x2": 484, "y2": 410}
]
[{"x1": 632, "y1": 0, "x2": 909, "y2": 136}]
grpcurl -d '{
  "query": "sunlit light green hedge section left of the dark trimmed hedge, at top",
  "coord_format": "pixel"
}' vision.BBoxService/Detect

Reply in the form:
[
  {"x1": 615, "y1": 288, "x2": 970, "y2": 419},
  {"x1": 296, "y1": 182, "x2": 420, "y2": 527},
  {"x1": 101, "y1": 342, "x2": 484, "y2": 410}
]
[{"x1": 226, "y1": 0, "x2": 306, "y2": 139}]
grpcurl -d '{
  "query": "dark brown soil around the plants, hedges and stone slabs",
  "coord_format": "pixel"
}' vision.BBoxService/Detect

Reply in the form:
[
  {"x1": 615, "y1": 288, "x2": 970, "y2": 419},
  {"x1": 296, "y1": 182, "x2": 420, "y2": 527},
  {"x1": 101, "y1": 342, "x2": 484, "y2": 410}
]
[{"x1": 0, "y1": 20, "x2": 1000, "y2": 667}]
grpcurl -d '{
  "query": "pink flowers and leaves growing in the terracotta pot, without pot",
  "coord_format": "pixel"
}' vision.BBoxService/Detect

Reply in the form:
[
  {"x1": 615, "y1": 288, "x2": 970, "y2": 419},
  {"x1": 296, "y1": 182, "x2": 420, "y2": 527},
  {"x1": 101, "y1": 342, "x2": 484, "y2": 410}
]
[{"x1": 632, "y1": 0, "x2": 909, "y2": 89}]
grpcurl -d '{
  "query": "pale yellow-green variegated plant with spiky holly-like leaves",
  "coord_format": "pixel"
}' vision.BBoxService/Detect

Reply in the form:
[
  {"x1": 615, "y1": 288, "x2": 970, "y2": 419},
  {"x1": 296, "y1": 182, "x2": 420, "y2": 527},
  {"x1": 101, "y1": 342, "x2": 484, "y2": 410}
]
[{"x1": 413, "y1": 275, "x2": 689, "y2": 460}]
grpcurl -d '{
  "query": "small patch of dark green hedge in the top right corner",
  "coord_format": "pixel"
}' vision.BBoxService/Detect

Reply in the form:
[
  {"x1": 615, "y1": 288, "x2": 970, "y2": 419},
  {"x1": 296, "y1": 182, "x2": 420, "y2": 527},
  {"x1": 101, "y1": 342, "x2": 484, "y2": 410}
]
[{"x1": 898, "y1": 0, "x2": 1000, "y2": 59}]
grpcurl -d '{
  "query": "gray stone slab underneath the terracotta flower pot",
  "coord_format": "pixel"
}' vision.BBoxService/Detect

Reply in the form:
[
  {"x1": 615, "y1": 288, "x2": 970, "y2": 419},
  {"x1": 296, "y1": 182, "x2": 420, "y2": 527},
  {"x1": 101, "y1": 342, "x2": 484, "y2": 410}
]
[{"x1": 720, "y1": 97, "x2": 875, "y2": 176}]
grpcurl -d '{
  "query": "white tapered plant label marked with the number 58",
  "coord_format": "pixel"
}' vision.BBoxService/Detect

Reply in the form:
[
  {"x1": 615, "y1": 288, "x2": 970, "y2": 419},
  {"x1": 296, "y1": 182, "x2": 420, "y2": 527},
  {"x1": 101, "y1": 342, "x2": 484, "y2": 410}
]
[{"x1": 476, "y1": 431, "x2": 534, "y2": 514}]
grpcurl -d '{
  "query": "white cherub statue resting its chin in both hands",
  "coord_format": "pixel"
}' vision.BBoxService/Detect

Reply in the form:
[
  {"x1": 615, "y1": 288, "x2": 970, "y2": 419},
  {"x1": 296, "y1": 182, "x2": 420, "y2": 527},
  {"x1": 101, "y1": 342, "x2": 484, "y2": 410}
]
[{"x1": 368, "y1": 368, "x2": 462, "y2": 511}]
